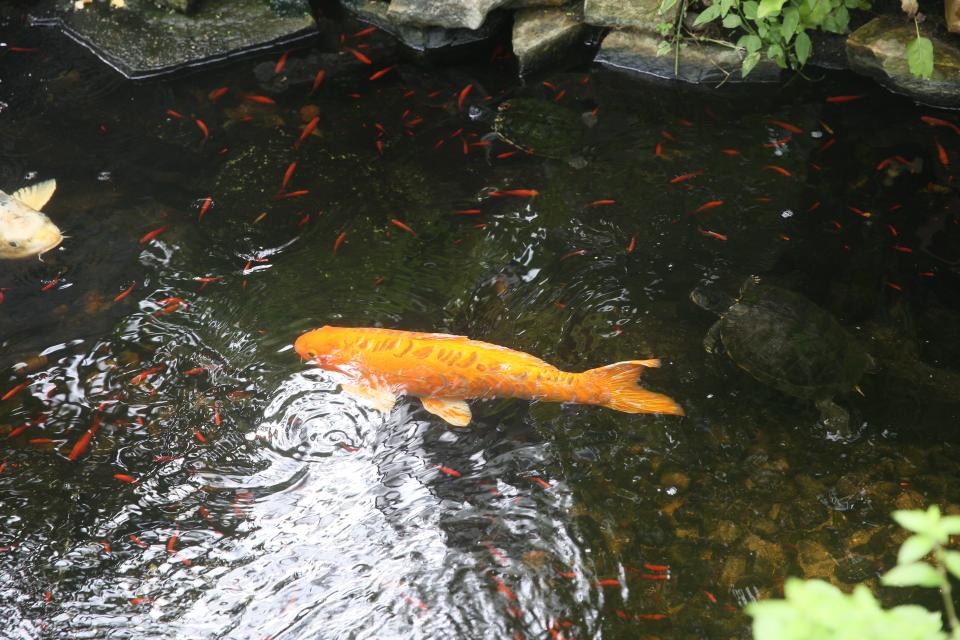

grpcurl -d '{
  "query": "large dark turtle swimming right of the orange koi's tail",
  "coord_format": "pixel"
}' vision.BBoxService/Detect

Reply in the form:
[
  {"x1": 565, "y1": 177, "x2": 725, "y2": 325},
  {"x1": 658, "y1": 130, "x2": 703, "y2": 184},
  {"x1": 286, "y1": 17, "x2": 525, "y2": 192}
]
[{"x1": 690, "y1": 277, "x2": 874, "y2": 434}]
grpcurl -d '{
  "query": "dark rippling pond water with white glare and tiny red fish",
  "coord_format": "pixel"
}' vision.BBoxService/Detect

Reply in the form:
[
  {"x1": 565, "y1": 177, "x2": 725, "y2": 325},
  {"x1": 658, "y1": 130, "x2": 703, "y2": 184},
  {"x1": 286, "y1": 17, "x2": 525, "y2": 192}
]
[{"x1": 0, "y1": 10, "x2": 960, "y2": 639}]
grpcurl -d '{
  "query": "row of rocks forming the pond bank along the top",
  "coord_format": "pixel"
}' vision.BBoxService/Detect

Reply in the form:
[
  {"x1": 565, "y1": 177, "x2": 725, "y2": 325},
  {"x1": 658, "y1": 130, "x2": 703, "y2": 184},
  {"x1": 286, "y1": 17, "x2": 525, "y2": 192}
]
[{"x1": 31, "y1": 0, "x2": 960, "y2": 108}]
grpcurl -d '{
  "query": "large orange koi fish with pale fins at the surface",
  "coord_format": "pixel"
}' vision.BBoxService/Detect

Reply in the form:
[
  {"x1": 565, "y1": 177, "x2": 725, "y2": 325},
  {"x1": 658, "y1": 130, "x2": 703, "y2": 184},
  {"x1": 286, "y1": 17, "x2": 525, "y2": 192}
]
[{"x1": 294, "y1": 327, "x2": 683, "y2": 427}]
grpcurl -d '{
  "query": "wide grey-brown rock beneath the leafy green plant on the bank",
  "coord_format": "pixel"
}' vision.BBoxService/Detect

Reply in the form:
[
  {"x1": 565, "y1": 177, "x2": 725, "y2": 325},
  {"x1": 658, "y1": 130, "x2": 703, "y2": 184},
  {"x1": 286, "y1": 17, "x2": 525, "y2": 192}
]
[{"x1": 596, "y1": 29, "x2": 780, "y2": 84}]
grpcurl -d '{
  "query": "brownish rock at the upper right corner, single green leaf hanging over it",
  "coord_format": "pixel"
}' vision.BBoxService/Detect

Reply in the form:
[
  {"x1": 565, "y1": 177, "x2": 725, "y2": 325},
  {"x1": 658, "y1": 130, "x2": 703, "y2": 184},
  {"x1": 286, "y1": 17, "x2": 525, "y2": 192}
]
[{"x1": 847, "y1": 16, "x2": 960, "y2": 108}]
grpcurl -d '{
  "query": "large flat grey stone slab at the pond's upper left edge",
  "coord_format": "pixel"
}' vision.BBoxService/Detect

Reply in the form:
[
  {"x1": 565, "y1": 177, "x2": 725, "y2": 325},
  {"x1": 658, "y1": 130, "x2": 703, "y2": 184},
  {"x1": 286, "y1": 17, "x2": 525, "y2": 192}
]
[{"x1": 30, "y1": 0, "x2": 316, "y2": 79}]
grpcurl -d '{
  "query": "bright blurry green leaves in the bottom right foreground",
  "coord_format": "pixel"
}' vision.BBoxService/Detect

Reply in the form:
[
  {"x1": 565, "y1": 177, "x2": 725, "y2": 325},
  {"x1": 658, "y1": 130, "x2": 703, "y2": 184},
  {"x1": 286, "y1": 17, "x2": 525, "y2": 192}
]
[{"x1": 747, "y1": 505, "x2": 960, "y2": 640}]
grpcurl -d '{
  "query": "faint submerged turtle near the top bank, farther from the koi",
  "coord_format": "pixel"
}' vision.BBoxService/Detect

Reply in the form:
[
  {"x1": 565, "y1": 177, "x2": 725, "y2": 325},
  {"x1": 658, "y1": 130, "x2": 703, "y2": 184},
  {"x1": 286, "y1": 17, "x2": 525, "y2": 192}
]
[{"x1": 493, "y1": 98, "x2": 590, "y2": 169}]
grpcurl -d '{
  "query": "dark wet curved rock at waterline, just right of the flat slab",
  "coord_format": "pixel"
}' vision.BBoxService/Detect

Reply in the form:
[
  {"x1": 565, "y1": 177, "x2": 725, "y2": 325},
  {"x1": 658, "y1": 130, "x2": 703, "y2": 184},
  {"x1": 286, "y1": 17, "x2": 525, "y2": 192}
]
[{"x1": 341, "y1": 0, "x2": 506, "y2": 52}]
